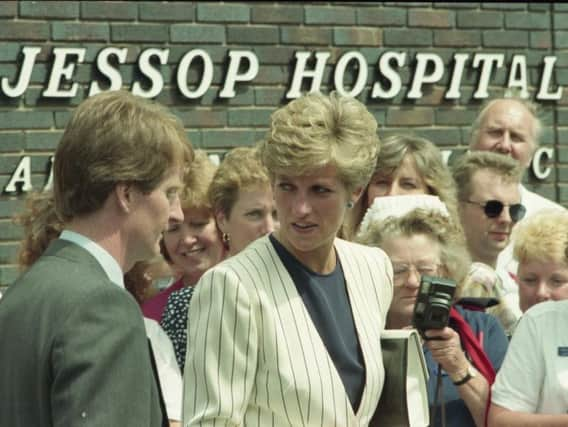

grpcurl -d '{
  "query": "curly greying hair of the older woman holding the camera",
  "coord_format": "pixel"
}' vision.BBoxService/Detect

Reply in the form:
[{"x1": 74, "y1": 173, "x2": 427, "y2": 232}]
[{"x1": 357, "y1": 209, "x2": 471, "y2": 299}]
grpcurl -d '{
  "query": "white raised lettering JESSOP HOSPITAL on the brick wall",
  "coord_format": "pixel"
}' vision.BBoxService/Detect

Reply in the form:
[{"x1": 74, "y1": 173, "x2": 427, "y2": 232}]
[{"x1": 0, "y1": 46, "x2": 562, "y2": 101}]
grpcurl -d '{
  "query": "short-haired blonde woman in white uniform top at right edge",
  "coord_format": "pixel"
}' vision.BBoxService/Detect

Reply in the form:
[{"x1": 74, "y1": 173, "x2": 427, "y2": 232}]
[{"x1": 490, "y1": 209, "x2": 568, "y2": 427}]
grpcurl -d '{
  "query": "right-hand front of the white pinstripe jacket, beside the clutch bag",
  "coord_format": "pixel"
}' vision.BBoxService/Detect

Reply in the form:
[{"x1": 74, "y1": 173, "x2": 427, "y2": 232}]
[{"x1": 335, "y1": 239, "x2": 384, "y2": 422}]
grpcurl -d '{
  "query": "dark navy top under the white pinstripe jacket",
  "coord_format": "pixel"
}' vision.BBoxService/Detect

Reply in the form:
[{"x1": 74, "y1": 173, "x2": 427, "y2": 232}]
[{"x1": 270, "y1": 235, "x2": 365, "y2": 412}]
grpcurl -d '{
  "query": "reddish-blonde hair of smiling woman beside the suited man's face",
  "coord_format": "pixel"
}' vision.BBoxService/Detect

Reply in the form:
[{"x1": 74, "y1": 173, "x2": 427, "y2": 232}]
[{"x1": 180, "y1": 150, "x2": 217, "y2": 214}]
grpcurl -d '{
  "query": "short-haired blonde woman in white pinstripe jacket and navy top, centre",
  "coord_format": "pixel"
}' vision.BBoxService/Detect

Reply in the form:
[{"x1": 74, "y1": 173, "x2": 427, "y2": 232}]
[{"x1": 184, "y1": 93, "x2": 392, "y2": 427}]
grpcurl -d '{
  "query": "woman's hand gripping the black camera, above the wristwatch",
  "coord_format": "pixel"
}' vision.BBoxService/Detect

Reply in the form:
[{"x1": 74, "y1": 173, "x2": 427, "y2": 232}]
[{"x1": 426, "y1": 326, "x2": 470, "y2": 381}]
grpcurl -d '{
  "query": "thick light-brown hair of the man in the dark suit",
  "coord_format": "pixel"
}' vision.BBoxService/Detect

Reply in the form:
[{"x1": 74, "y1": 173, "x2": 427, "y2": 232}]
[{"x1": 53, "y1": 91, "x2": 193, "y2": 220}]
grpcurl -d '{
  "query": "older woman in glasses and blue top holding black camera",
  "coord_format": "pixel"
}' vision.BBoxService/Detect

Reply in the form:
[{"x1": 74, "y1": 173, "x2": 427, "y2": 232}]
[{"x1": 358, "y1": 209, "x2": 508, "y2": 427}]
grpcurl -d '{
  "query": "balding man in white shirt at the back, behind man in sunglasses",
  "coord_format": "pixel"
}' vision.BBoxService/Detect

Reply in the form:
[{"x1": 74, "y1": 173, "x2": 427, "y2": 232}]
[{"x1": 469, "y1": 98, "x2": 564, "y2": 320}]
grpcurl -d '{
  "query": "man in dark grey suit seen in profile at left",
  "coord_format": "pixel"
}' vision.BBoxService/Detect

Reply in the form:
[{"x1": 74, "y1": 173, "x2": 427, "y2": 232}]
[{"x1": 0, "y1": 91, "x2": 193, "y2": 427}]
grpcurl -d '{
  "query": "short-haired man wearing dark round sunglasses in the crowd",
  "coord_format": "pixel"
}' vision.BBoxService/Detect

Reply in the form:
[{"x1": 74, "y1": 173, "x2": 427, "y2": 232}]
[{"x1": 452, "y1": 151, "x2": 526, "y2": 317}]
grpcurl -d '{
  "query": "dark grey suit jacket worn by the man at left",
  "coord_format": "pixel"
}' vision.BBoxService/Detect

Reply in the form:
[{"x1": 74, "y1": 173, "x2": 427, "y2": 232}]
[{"x1": 0, "y1": 240, "x2": 162, "y2": 427}]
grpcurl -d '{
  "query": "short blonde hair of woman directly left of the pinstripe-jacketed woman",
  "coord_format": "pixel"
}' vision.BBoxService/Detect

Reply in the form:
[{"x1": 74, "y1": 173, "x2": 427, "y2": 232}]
[{"x1": 209, "y1": 147, "x2": 270, "y2": 218}]
